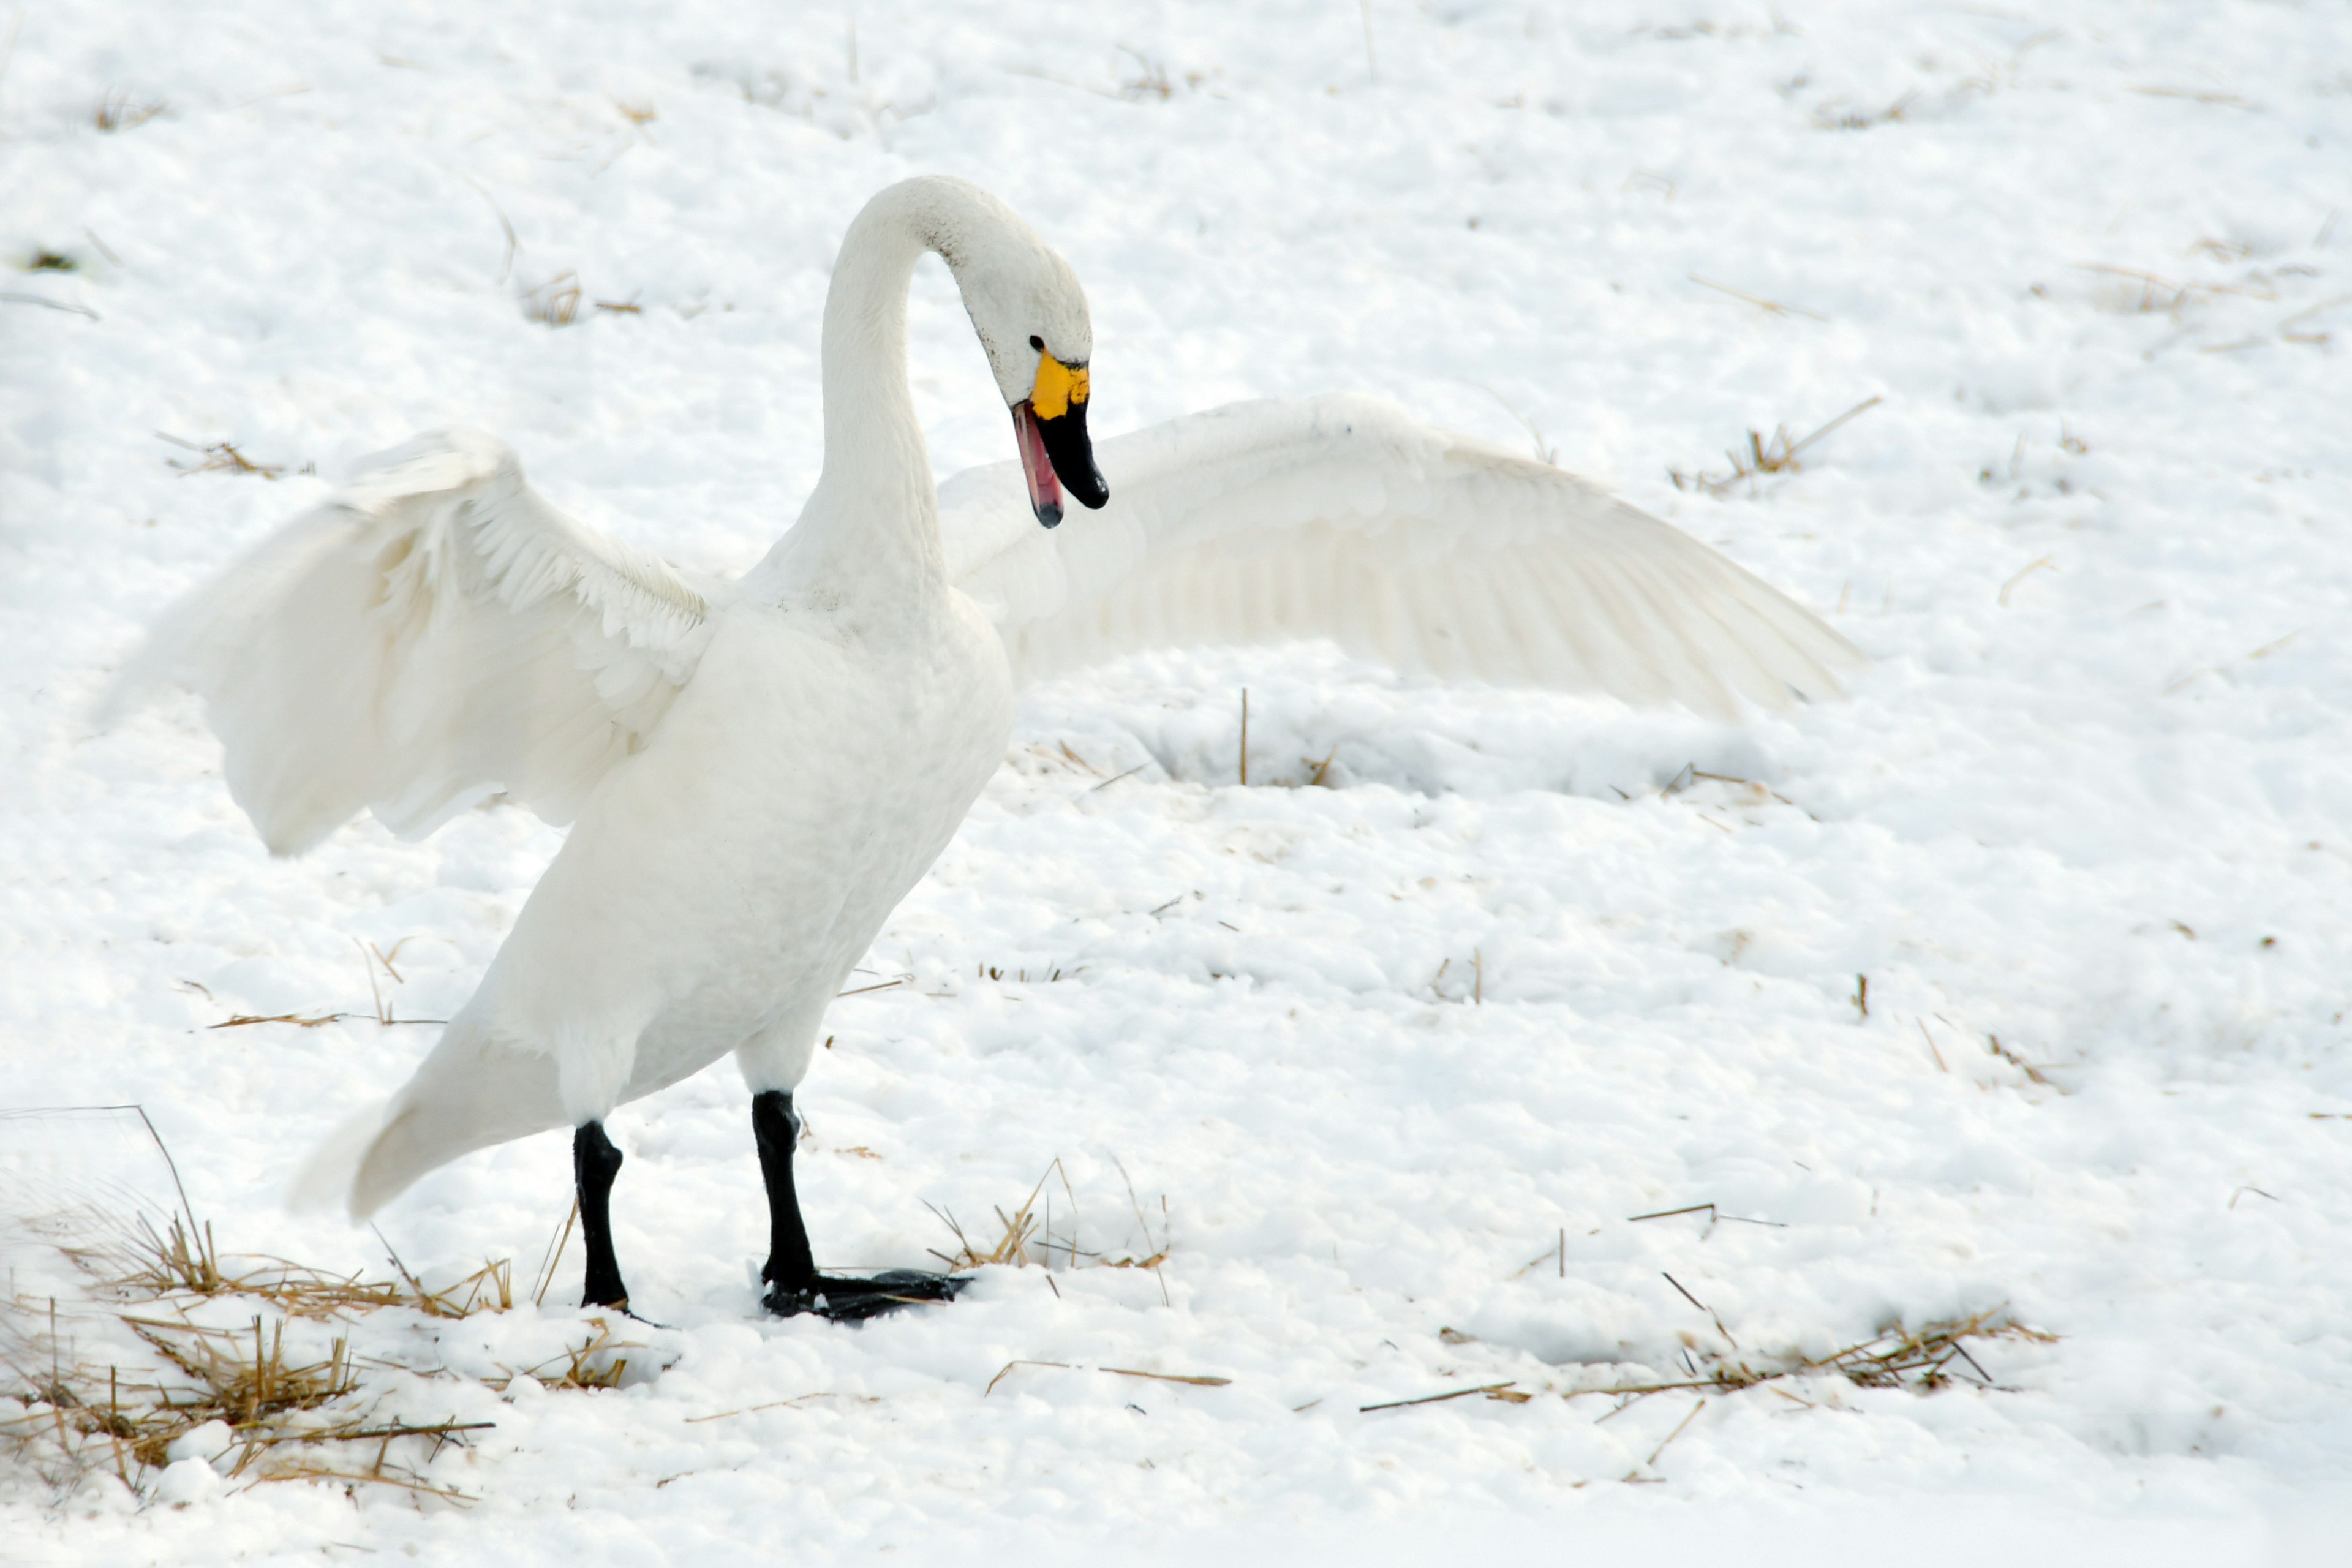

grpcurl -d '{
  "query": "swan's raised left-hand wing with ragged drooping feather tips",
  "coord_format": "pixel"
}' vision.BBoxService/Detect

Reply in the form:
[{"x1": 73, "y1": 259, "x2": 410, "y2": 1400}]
[{"x1": 101, "y1": 430, "x2": 717, "y2": 856}]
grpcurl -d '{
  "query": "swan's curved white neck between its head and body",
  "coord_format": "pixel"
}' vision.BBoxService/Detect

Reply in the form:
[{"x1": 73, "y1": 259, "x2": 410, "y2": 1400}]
[{"x1": 786, "y1": 181, "x2": 986, "y2": 604}]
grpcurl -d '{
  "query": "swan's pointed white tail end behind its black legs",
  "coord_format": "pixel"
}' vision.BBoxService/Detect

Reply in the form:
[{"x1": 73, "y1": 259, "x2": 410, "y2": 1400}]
[{"x1": 287, "y1": 1013, "x2": 567, "y2": 1220}]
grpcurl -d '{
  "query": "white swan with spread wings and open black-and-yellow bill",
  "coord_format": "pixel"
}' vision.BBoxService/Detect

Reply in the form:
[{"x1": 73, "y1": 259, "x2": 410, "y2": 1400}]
[{"x1": 101, "y1": 176, "x2": 1860, "y2": 1319}]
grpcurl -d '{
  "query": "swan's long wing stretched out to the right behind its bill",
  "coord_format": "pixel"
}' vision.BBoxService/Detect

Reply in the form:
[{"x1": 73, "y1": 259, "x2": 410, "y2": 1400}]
[{"x1": 938, "y1": 395, "x2": 1860, "y2": 715}]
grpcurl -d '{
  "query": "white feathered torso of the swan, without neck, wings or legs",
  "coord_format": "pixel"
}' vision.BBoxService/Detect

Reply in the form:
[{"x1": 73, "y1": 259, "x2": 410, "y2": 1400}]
[{"x1": 341, "y1": 590, "x2": 1014, "y2": 1213}]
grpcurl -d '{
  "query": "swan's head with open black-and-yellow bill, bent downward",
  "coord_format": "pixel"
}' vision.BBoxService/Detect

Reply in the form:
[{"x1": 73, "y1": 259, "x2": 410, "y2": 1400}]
[{"x1": 950, "y1": 214, "x2": 1110, "y2": 529}]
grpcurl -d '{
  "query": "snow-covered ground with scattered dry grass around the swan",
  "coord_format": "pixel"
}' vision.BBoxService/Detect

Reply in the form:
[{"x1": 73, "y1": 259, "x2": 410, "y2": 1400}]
[{"x1": 0, "y1": 0, "x2": 2352, "y2": 1563}]
